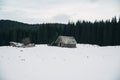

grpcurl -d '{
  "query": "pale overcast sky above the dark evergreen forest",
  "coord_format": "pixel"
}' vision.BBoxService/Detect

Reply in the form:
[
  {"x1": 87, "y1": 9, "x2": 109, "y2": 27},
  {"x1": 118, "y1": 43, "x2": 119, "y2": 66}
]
[{"x1": 0, "y1": 0, "x2": 120, "y2": 23}]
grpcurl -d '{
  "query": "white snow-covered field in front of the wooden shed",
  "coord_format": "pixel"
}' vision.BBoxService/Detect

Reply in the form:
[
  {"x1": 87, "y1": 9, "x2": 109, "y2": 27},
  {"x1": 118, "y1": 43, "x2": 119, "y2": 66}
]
[{"x1": 0, "y1": 44, "x2": 120, "y2": 80}]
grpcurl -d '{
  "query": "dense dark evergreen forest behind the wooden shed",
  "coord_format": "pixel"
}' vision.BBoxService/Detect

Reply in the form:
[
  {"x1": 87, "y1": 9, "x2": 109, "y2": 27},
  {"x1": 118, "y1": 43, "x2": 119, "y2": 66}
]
[{"x1": 0, "y1": 17, "x2": 120, "y2": 46}]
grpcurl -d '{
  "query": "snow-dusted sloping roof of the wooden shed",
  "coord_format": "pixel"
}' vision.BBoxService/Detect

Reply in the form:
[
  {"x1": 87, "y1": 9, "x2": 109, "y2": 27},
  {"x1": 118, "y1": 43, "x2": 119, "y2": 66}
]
[{"x1": 56, "y1": 36, "x2": 77, "y2": 44}]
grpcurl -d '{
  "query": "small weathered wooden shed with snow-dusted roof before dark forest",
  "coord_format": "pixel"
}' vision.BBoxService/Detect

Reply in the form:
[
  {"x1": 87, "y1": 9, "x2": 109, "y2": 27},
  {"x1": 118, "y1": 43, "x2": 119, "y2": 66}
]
[{"x1": 55, "y1": 36, "x2": 77, "y2": 48}]
